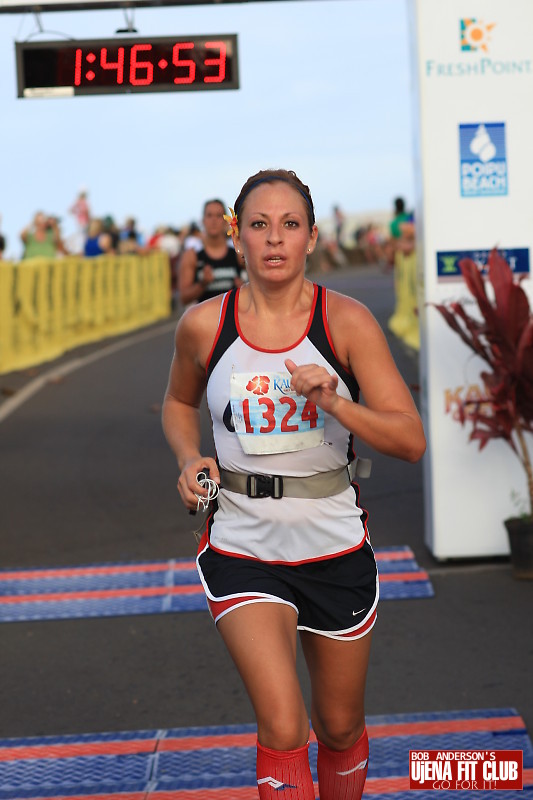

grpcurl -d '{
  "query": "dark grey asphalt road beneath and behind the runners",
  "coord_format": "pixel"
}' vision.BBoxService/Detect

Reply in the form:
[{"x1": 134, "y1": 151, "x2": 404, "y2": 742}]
[{"x1": 0, "y1": 268, "x2": 533, "y2": 738}]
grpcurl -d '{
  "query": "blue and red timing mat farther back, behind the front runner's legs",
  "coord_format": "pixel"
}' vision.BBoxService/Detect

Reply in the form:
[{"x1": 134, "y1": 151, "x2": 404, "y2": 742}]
[{"x1": 0, "y1": 547, "x2": 434, "y2": 620}]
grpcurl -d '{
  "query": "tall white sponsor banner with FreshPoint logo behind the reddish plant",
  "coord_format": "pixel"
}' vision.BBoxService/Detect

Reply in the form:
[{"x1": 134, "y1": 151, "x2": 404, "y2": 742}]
[{"x1": 411, "y1": 0, "x2": 533, "y2": 559}]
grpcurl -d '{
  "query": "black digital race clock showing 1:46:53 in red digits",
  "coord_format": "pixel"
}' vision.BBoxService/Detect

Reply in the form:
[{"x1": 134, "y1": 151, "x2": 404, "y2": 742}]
[{"x1": 16, "y1": 34, "x2": 239, "y2": 97}]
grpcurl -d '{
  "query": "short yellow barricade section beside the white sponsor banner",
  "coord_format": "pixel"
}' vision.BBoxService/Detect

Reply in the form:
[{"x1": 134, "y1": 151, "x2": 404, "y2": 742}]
[{"x1": 388, "y1": 250, "x2": 420, "y2": 350}]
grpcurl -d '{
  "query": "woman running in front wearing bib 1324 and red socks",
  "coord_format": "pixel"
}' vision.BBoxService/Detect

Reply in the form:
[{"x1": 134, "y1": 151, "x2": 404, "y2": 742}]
[{"x1": 163, "y1": 170, "x2": 425, "y2": 800}]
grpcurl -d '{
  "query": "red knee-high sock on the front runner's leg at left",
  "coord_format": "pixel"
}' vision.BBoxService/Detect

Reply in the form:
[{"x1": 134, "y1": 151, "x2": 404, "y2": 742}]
[{"x1": 257, "y1": 742, "x2": 315, "y2": 800}]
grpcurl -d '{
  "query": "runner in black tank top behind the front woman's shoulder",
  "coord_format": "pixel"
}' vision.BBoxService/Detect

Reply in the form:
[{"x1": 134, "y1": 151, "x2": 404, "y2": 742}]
[{"x1": 178, "y1": 200, "x2": 246, "y2": 305}]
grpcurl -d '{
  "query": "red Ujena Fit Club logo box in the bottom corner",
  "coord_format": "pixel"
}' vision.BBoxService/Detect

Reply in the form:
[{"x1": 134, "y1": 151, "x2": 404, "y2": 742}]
[{"x1": 409, "y1": 750, "x2": 523, "y2": 792}]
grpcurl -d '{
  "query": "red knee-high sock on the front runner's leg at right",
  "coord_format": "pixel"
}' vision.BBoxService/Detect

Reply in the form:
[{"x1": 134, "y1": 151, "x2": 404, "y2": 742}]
[{"x1": 317, "y1": 728, "x2": 368, "y2": 800}]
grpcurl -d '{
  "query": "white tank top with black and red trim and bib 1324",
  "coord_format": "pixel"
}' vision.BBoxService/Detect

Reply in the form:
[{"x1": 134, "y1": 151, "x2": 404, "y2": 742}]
[{"x1": 207, "y1": 284, "x2": 367, "y2": 564}]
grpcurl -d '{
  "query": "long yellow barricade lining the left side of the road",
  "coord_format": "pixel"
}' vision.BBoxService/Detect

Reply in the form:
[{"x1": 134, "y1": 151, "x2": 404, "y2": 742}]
[{"x1": 0, "y1": 252, "x2": 171, "y2": 374}]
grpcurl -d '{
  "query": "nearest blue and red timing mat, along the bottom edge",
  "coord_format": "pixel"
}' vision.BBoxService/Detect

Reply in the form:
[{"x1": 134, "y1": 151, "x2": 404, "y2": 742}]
[{"x1": 0, "y1": 709, "x2": 533, "y2": 800}]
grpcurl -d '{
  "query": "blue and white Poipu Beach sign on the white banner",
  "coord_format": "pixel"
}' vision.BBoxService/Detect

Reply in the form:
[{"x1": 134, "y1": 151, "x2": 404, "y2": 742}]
[{"x1": 459, "y1": 122, "x2": 508, "y2": 197}]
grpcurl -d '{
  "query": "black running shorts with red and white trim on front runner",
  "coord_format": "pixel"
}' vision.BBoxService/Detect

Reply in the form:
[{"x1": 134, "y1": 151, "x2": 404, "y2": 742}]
[{"x1": 197, "y1": 537, "x2": 379, "y2": 639}]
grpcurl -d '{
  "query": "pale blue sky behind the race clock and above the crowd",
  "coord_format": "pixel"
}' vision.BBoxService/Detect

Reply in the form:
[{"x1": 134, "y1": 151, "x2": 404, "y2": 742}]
[{"x1": 0, "y1": 0, "x2": 414, "y2": 258}]
